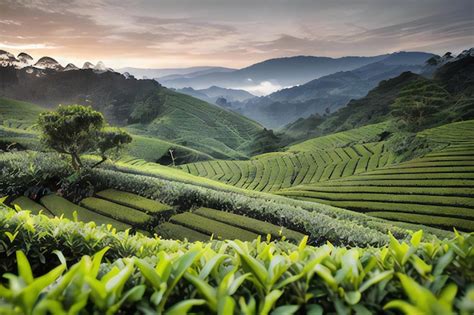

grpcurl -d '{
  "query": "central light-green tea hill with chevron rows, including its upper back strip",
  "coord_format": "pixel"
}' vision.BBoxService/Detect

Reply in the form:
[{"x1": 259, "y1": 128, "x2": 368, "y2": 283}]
[{"x1": 180, "y1": 123, "x2": 396, "y2": 192}]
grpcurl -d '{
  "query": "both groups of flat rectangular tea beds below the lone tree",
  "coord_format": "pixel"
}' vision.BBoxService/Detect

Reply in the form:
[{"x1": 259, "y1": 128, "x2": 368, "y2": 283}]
[{"x1": 11, "y1": 189, "x2": 304, "y2": 242}]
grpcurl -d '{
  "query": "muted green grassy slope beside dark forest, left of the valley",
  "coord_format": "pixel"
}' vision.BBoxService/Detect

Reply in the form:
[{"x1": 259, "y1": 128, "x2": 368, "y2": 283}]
[{"x1": 129, "y1": 91, "x2": 263, "y2": 158}]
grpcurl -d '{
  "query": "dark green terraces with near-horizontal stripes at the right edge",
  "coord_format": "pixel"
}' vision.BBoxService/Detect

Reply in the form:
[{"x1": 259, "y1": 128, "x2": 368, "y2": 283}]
[{"x1": 278, "y1": 141, "x2": 474, "y2": 230}]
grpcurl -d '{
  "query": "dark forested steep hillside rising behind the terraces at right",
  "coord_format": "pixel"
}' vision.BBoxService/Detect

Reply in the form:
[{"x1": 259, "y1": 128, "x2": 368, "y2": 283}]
[{"x1": 283, "y1": 56, "x2": 474, "y2": 140}]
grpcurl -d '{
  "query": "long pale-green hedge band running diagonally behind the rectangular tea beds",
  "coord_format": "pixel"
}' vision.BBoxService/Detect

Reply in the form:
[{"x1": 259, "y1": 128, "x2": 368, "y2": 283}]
[{"x1": 0, "y1": 152, "x2": 452, "y2": 246}]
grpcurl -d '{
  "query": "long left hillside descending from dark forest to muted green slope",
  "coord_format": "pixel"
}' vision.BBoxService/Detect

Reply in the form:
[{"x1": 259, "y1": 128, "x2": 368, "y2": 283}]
[{"x1": 0, "y1": 67, "x2": 273, "y2": 161}]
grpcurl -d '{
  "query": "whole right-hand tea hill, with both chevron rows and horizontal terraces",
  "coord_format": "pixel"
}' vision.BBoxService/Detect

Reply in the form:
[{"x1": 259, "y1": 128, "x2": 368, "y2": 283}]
[{"x1": 181, "y1": 120, "x2": 474, "y2": 230}]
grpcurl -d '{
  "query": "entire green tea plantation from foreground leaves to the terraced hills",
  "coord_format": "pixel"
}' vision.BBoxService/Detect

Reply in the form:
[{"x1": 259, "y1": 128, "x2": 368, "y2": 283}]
[{"x1": 0, "y1": 100, "x2": 474, "y2": 315}]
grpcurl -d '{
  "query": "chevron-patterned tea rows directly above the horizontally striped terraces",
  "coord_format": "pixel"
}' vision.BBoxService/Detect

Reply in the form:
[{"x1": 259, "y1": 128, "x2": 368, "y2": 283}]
[{"x1": 181, "y1": 142, "x2": 395, "y2": 191}]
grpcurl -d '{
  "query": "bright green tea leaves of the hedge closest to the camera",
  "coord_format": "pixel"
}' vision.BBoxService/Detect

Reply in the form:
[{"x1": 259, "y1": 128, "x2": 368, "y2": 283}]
[{"x1": 0, "y1": 208, "x2": 474, "y2": 315}]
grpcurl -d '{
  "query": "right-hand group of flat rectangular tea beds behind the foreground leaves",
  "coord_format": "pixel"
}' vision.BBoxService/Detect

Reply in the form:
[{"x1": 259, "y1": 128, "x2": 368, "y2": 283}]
[{"x1": 156, "y1": 208, "x2": 304, "y2": 242}]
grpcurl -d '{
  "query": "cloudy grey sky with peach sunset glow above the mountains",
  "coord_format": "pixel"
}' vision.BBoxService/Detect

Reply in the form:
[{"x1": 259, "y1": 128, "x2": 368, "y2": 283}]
[{"x1": 0, "y1": 0, "x2": 474, "y2": 68}]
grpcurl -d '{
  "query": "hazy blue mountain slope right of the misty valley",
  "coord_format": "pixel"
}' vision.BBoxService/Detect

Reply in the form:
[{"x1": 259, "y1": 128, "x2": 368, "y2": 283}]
[{"x1": 231, "y1": 52, "x2": 434, "y2": 128}]
